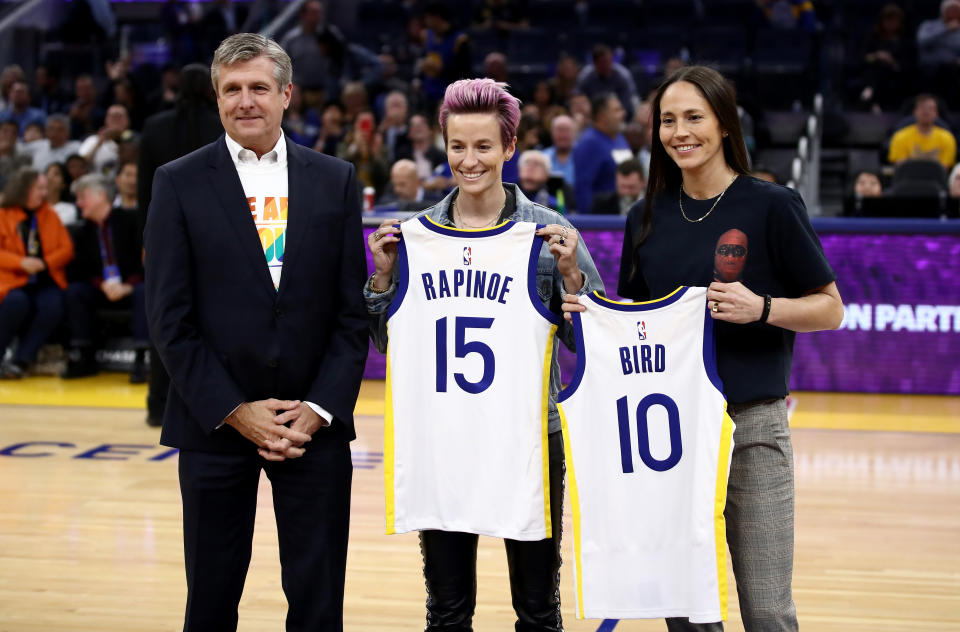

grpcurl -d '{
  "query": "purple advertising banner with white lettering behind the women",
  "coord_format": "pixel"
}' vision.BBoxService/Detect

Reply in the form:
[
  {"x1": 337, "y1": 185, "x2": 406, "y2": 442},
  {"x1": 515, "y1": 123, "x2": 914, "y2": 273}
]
[{"x1": 365, "y1": 218, "x2": 960, "y2": 395}]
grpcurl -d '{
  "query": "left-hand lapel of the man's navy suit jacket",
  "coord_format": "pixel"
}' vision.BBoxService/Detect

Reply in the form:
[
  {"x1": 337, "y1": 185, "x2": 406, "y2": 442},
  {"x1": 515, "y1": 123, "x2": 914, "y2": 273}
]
[{"x1": 209, "y1": 136, "x2": 276, "y2": 299}]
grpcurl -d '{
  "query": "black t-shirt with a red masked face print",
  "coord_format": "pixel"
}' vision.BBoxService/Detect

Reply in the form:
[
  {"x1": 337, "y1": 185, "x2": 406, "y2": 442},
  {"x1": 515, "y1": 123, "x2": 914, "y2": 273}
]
[{"x1": 617, "y1": 176, "x2": 836, "y2": 403}]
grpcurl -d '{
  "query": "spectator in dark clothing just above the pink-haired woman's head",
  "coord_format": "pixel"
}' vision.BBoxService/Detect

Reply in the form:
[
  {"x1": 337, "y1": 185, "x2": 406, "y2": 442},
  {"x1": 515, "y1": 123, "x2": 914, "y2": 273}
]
[{"x1": 420, "y1": 0, "x2": 473, "y2": 107}]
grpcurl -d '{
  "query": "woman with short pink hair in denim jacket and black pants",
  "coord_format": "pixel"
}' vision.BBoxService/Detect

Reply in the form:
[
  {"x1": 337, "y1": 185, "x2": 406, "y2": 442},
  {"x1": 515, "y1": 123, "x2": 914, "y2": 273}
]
[{"x1": 364, "y1": 79, "x2": 603, "y2": 631}]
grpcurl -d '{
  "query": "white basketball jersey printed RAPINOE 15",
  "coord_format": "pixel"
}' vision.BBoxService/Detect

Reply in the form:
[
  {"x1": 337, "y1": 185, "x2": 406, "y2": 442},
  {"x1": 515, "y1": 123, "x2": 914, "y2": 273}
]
[{"x1": 384, "y1": 216, "x2": 559, "y2": 540}]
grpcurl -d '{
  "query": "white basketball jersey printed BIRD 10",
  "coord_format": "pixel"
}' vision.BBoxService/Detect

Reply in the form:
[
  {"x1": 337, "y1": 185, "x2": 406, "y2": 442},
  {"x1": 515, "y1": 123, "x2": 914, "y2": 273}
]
[{"x1": 558, "y1": 287, "x2": 734, "y2": 623}]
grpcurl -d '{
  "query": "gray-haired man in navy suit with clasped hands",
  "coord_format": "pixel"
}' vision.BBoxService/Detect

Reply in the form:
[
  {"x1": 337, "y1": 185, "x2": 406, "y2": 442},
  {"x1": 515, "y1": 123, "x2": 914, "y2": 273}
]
[{"x1": 145, "y1": 33, "x2": 367, "y2": 632}]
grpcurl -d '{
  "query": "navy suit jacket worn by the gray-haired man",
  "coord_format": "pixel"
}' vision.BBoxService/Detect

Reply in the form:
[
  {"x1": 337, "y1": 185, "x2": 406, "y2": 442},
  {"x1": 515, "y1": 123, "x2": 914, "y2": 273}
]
[{"x1": 144, "y1": 136, "x2": 367, "y2": 452}]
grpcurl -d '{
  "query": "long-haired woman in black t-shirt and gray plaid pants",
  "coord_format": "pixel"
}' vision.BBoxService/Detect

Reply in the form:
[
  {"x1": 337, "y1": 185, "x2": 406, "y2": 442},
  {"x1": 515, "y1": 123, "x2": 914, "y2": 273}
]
[{"x1": 564, "y1": 66, "x2": 843, "y2": 632}]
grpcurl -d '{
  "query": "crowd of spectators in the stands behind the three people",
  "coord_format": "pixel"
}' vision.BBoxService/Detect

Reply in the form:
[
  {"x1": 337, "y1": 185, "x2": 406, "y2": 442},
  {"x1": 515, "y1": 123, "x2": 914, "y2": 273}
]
[{"x1": 0, "y1": 0, "x2": 960, "y2": 381}]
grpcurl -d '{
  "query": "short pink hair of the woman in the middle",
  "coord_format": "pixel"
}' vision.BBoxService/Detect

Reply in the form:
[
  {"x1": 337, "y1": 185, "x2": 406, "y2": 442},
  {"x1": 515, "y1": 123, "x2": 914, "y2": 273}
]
[{"x1": 440, "y1": 79, "x2": 520, "y2": 148}]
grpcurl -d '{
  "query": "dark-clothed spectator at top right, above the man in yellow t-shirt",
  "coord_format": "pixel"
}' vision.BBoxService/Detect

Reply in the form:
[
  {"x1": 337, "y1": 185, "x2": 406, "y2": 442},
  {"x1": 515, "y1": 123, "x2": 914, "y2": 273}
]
[{"x1": 857, "y1": 2, "x2": 917, "y2": 109}]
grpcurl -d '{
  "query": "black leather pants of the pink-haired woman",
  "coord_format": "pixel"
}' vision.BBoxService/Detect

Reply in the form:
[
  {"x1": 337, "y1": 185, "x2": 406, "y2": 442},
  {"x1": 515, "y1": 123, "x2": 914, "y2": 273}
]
[{"x1": 420, "y1": 432, "x2": 564, "y2": 632}]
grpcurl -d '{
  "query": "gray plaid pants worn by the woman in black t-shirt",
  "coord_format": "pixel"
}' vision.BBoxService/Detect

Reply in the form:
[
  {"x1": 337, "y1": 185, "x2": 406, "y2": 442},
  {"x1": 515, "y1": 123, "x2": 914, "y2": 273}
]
[{"x1": 667, "y1": 399, "x2": 798, "y2": 632}]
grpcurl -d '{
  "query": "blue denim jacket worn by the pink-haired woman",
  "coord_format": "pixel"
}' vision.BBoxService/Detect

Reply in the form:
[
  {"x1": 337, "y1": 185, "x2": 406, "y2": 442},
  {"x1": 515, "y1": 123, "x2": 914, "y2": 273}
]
[{"x1": 363, "y1": 183, "x2": 604, "y2": 433}]
